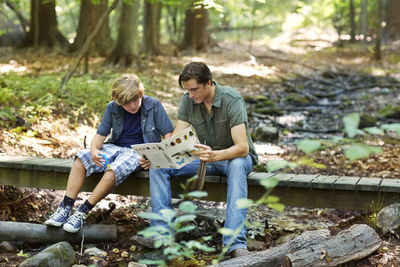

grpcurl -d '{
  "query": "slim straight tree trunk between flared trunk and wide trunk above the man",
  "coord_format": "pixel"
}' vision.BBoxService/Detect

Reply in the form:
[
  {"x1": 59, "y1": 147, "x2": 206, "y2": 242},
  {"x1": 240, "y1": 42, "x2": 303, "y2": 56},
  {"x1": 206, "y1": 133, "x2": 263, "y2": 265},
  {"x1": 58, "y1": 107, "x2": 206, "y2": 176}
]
[{"x1": 143, "y1": 0, "x2": 162, "y2": 56}]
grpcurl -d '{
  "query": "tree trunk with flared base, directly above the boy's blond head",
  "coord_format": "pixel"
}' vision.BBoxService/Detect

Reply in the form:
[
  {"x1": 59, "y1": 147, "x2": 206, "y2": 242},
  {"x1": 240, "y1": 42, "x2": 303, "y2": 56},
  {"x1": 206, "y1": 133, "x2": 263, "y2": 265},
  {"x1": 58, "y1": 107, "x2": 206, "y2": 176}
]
[{"x1": 106, "y1": 0, "x2": 140, "y2": 67}]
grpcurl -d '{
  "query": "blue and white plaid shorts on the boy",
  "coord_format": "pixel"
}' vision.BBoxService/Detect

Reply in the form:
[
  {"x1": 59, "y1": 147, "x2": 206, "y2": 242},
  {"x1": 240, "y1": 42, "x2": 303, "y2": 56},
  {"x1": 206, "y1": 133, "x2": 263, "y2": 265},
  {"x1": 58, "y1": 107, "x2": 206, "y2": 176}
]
[{"x1": 76, "y1": 144, "x2": 141, "y2": 186}]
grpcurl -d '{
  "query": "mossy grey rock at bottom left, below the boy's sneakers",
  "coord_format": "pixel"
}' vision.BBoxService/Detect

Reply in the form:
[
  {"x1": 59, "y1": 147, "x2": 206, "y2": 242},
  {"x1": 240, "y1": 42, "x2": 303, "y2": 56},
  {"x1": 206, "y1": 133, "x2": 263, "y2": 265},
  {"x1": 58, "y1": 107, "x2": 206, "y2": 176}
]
[{"x1": 20, "y1": 241, "x2": 76, "y2": 267}]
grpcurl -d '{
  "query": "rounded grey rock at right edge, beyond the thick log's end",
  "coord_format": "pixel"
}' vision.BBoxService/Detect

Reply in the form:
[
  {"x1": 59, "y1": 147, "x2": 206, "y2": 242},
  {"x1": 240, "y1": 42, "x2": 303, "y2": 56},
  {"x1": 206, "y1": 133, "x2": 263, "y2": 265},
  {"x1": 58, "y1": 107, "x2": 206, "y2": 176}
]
[{"x1": 376, "y1": 203, "x2": 400, "y2": 238}]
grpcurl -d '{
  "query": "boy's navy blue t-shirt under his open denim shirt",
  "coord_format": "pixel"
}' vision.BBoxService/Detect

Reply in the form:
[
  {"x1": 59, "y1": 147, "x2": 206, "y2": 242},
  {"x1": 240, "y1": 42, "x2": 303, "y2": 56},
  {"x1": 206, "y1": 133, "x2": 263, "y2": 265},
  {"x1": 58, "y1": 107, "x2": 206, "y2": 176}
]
[{"x1": 115, "y1": 107, "x2": 144, "y2": 147}]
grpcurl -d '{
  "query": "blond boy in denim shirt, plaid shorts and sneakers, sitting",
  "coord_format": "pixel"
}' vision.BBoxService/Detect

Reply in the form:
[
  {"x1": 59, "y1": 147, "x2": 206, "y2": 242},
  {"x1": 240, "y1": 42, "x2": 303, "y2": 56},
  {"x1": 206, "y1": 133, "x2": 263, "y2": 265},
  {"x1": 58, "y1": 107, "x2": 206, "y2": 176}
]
[{"x1": 45, "y1": 74, "x2": 173, "y2": 233}]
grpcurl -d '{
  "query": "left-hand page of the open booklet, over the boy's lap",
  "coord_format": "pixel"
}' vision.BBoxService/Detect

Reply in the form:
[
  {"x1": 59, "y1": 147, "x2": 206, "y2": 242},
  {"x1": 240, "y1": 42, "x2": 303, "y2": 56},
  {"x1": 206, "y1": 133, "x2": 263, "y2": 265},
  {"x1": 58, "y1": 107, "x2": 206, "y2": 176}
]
[{"x1": 131, "y1": 143, "x2": 176, "y2": 169}]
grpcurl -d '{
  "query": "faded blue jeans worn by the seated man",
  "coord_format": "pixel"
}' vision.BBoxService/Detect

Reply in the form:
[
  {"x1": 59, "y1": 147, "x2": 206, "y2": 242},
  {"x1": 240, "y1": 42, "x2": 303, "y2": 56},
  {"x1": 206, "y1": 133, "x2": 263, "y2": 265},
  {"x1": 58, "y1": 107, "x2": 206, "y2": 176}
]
[{"x1": 150, "y1": 155, "x2": 253, "y2": 253}]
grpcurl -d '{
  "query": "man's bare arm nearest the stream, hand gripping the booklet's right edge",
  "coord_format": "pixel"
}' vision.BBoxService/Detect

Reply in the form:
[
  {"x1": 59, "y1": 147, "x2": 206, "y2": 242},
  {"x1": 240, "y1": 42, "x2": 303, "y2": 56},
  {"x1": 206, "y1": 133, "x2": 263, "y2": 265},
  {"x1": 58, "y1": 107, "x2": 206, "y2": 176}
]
[{"x1": 195, "y1": 123, "x2": 249, "y2": 162}]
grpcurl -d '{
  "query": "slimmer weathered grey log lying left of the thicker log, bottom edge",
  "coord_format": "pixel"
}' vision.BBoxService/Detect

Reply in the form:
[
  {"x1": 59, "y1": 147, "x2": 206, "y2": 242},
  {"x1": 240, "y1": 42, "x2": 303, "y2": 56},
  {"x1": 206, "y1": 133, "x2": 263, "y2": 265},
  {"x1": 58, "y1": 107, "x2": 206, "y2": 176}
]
[{"x1": 212, "y1": 229, "x2": 330, "y2": 267}]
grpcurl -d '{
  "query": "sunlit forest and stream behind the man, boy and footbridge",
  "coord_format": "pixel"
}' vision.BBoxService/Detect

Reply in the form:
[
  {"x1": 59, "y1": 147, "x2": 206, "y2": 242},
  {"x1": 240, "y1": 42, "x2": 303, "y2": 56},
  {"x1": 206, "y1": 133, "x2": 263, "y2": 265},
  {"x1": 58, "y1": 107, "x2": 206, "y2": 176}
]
[{"x1": 0, "y1": 0, "x2": 400, "y2": 176}]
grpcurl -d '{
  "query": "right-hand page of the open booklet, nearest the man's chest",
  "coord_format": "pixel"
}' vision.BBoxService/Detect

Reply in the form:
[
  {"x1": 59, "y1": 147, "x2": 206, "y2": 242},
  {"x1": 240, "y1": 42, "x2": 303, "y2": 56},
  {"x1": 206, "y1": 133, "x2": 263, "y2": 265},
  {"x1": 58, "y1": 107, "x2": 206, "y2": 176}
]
[{"x1": 161, "y1": 127, "x2": 200, "y2": 169}]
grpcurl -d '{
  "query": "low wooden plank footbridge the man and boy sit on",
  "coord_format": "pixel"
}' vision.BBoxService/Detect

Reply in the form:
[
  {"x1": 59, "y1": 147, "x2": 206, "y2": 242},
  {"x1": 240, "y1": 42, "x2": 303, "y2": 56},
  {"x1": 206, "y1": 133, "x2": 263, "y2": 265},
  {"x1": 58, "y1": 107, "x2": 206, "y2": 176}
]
[{"x1": 0, "y1": 154, "x2": 400, "y2": 211}]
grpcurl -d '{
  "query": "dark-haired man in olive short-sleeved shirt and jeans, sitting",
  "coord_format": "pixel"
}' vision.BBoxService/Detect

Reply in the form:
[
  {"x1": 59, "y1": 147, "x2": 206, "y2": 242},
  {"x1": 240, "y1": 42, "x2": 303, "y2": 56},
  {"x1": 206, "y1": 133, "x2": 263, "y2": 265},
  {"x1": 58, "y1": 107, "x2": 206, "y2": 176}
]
[{"x1": 136, "y1": 62, "x2": 257, "y2": 257}]
